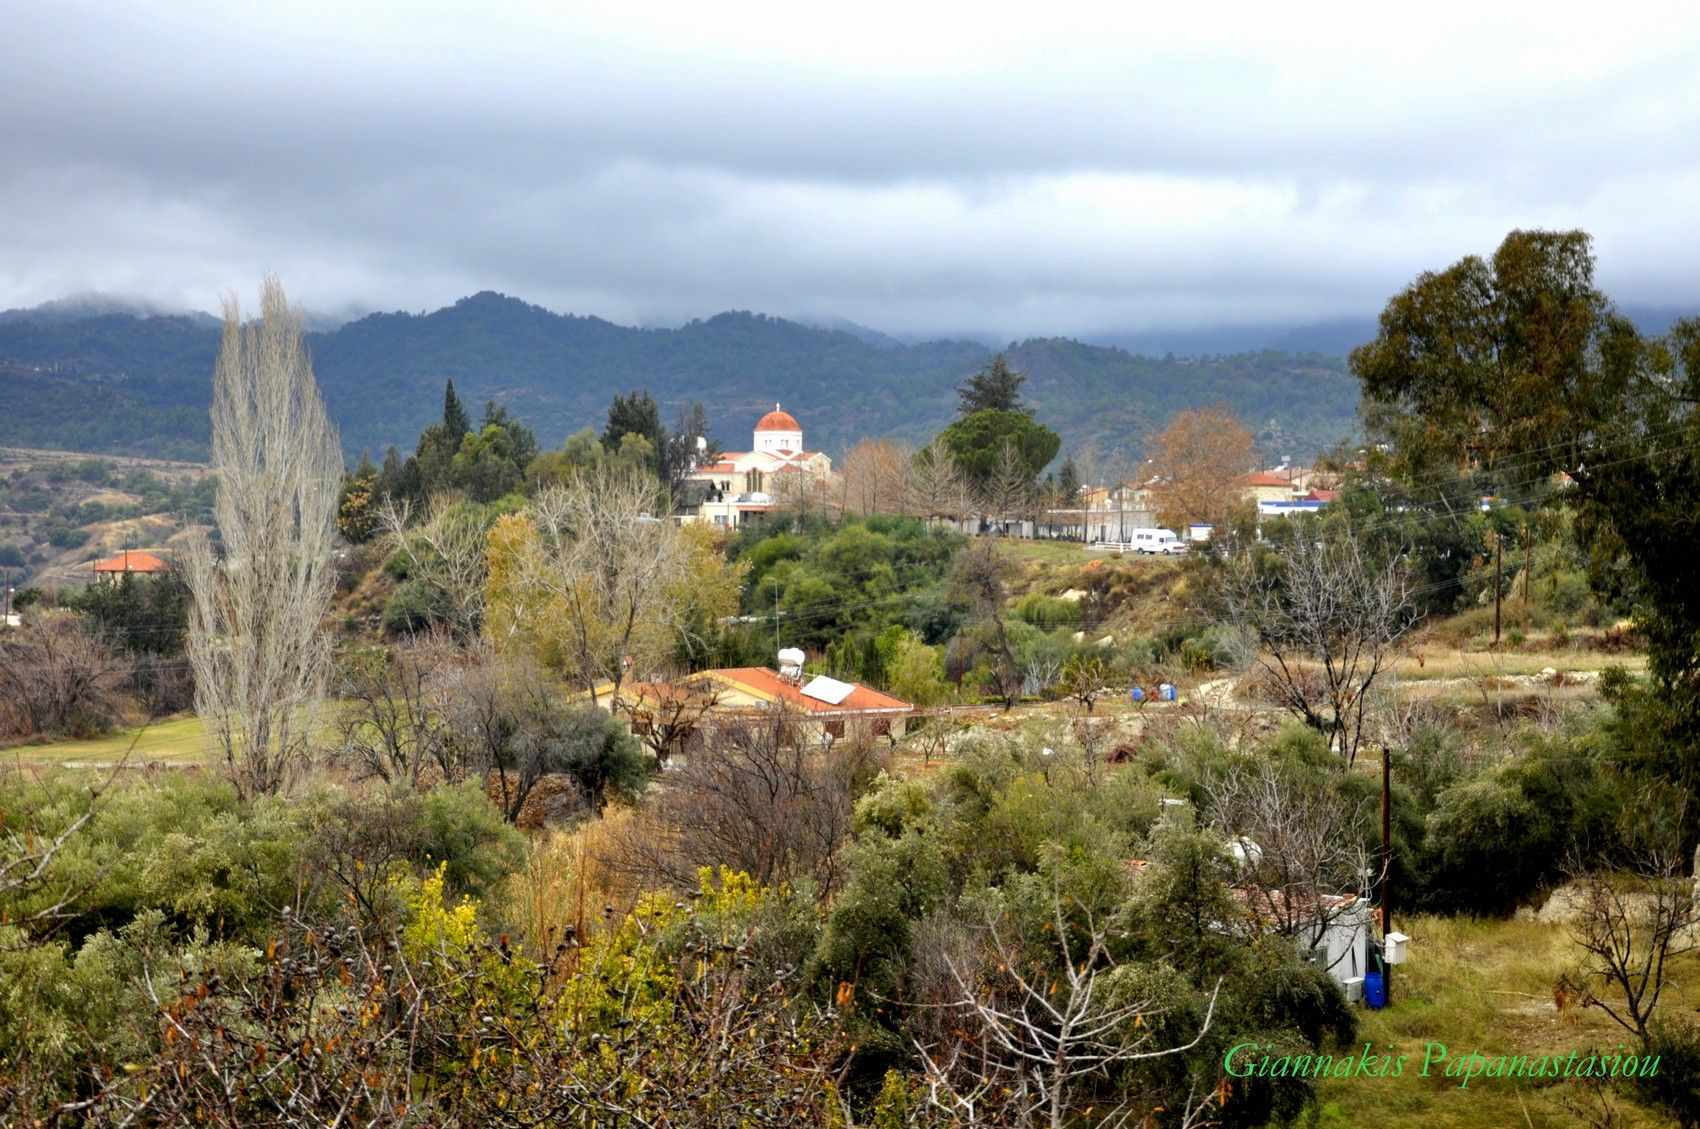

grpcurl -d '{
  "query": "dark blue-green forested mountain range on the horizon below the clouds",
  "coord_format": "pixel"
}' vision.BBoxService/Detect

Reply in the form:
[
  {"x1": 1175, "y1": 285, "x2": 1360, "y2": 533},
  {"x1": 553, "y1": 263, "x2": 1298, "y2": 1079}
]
[{"x1": 0, "y1": 291, "x2": 1357, "y2": 457}]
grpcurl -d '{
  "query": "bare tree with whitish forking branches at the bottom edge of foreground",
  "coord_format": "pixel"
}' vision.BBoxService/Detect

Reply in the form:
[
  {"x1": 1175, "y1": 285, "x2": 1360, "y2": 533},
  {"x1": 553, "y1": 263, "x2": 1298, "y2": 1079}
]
[{"x1": 916, "y1": 893, "x2": 1221, "y2": 1129}]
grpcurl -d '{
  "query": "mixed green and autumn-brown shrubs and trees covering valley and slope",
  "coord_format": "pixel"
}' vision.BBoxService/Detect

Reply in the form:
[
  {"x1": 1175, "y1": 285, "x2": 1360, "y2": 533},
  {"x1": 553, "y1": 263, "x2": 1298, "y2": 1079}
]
[{"x1": 0, "y1": 233, "x2": 1700, "y2": 1127}]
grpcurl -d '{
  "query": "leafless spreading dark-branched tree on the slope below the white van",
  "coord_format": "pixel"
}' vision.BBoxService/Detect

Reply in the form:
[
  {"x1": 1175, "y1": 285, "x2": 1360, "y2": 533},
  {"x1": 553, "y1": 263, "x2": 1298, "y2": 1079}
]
[{"x1": 1221, "y1": 530, "x2": 1416, "y2": 765}]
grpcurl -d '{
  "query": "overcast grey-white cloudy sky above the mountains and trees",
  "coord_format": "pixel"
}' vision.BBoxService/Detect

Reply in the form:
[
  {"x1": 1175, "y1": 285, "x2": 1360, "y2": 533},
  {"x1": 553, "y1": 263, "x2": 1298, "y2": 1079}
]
[{"x1": 0, "y1": 0, "x2": 1700, "y2": 337}]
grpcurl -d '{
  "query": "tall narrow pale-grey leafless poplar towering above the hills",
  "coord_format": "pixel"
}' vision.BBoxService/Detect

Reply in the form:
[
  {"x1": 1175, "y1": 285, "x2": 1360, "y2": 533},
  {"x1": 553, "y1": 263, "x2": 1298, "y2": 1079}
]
[{"x1": 187, "y1": 279, "x2": 342, "y2": 796}]
